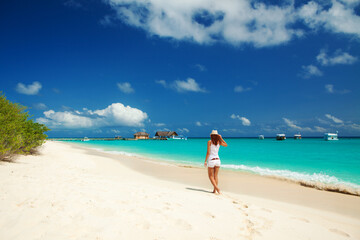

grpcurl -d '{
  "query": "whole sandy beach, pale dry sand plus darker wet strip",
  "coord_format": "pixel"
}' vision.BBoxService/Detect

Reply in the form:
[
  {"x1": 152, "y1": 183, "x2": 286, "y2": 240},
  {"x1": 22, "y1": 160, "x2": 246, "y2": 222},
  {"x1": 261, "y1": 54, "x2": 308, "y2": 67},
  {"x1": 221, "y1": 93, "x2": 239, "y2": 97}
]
[{"x1": 0, "y1": 141, "x2": 360, "y2": 240}]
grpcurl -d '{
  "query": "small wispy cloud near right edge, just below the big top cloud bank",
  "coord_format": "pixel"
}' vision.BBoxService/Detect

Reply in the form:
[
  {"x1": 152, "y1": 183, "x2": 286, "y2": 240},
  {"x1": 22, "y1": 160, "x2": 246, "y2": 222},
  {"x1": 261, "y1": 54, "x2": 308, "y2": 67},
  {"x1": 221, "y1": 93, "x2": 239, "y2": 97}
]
[{"x1": 316, "y1": 49, "x2": 357, "y2": 66}]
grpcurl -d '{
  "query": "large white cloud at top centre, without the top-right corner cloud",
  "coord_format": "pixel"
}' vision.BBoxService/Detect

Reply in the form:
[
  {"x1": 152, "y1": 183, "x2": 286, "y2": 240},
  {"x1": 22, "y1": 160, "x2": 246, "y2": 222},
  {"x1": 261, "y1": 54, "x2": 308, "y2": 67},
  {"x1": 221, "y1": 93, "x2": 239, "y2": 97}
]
[{"x1": 107, "y1": 0, "x2": 300, "y2": 47}]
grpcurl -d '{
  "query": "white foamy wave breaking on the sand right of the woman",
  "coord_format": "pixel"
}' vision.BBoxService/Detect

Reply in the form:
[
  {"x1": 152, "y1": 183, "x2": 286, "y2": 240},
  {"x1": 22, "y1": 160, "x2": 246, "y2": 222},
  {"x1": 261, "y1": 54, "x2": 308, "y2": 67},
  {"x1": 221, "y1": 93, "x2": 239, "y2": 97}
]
[{"x1": 222, "y1": 164, "x2": 360, "y2": 196}]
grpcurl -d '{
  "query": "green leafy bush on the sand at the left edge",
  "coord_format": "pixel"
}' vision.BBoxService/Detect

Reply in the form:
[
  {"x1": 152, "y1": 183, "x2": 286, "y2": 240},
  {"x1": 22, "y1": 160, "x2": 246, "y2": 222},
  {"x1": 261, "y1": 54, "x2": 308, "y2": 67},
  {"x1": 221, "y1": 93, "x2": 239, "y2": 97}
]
[{"x1": 0, "y1": 93, "x2": 50, "y2": 161}]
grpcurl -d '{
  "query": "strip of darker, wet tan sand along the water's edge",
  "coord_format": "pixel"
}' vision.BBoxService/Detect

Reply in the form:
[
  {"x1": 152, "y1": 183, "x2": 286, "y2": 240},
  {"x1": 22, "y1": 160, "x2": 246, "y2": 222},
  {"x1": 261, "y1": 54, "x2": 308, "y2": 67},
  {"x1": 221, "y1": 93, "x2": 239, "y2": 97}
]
[{"x1": 65, "y1": 143, "x2": 360, "y2": 219}]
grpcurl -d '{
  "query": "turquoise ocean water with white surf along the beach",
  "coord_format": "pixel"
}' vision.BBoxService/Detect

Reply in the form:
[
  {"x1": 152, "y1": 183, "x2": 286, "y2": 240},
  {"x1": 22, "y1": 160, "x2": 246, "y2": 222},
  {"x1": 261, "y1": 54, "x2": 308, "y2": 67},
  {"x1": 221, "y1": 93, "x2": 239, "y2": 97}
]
[{"x1": 65, "y1": 138, "x2": 360, "y2": 195}]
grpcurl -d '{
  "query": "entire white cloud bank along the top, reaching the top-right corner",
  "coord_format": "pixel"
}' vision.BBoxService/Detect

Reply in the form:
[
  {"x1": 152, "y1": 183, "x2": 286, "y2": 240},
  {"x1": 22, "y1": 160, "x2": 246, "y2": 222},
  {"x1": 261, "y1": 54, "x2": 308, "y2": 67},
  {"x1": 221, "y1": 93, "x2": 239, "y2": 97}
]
[{"x1": 105, "y1": 0, "x2": 360, "y2": 47}]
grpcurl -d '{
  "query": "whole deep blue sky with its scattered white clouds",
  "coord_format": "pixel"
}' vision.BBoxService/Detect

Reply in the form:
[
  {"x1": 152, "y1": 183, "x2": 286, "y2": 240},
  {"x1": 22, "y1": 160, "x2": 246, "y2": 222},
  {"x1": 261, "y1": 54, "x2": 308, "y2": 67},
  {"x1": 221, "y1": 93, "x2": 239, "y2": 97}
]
[{"x1": 0, "y1": 0, "x2": 360, "y2": 137}]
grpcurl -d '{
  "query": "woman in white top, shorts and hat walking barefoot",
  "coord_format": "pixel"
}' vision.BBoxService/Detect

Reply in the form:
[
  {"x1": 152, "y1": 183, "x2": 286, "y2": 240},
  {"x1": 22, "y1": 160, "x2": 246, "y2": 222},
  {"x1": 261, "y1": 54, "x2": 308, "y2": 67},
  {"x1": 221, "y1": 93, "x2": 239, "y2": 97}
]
[{"x1": 204, "y1": 130, "x2": 227, "y2": 194}]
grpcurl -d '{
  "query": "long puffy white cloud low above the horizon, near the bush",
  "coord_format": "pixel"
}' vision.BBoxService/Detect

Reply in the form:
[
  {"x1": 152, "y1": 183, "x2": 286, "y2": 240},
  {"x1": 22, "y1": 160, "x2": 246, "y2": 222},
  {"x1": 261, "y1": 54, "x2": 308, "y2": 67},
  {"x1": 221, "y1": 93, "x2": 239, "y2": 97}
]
[{"x1": 36, "y1": 103, "x2": 148, "y2": 128}]
